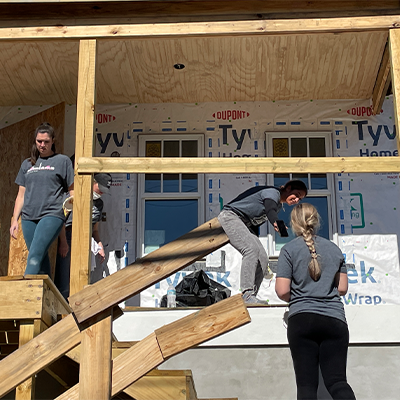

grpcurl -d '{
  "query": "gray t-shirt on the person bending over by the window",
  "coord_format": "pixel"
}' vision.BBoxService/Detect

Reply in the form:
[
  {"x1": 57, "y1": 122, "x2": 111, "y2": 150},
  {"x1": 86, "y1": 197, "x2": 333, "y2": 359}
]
[{"x1": 224, "y1": 186, "x2": 282, "y2": 226}]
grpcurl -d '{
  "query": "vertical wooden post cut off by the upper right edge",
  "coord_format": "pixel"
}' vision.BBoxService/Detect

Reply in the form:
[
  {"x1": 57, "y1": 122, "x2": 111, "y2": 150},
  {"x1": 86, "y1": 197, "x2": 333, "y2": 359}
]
[{"x1": 389, "y1": 29, "x2": 400, "y2": 151}]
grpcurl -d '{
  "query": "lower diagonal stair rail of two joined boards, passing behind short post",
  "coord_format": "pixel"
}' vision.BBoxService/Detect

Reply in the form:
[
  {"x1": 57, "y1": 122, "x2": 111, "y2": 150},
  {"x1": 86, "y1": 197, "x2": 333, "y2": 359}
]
[{"x1": 56, "y1": 294, "x2": 250, "y2": 400}]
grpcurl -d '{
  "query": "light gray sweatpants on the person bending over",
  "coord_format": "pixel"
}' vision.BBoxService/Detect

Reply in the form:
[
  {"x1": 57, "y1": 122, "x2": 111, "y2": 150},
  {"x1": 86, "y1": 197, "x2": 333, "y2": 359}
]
[{"x1": 218, "y1": 210, "x2": 268, "y2": 294}]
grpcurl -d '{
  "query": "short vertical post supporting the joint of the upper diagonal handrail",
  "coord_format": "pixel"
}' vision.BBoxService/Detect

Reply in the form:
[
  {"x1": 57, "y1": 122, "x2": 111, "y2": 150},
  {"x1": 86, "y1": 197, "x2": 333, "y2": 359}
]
[{"x1": 79, "y1": 308, "x2": 112, "y2": 400}]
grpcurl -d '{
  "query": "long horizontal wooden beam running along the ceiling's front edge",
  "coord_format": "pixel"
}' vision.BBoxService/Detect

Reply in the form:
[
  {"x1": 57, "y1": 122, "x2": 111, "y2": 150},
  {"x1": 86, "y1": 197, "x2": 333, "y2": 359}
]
[{"x1": 0, "y1": 15, "x2": 400, "y2": 40}]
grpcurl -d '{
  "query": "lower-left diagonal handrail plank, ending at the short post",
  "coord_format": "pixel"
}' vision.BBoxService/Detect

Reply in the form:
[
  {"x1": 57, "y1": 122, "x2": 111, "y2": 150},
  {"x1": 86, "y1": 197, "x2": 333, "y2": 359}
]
[{"x1": 0, "y1": 314, "x2": 81, "y2": 397}]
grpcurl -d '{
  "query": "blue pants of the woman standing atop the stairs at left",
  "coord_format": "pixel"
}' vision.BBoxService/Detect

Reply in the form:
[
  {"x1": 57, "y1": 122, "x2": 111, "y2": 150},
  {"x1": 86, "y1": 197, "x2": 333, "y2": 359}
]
[{"x1": 21, "y1": 216, "x2": 64, "y2": 277}]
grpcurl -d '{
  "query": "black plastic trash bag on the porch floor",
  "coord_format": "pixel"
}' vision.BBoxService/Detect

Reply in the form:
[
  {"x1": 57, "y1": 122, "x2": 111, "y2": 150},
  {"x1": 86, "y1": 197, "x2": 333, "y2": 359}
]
[{"x1": 160, "y1": 270, "x2": 231, "y2": 307}]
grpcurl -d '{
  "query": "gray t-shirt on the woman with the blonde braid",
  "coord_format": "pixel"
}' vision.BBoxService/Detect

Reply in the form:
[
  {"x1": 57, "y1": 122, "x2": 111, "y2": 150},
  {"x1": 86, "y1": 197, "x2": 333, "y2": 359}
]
[{"x1": 276, "y1": 236, "x2": 347, "y2": 322}]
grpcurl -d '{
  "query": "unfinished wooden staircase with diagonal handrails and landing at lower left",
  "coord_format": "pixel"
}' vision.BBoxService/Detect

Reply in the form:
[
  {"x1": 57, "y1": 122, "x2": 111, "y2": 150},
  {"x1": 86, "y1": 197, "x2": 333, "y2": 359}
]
[{"x1": 0, "y1": 218, "x2": 250, "y2": 400}]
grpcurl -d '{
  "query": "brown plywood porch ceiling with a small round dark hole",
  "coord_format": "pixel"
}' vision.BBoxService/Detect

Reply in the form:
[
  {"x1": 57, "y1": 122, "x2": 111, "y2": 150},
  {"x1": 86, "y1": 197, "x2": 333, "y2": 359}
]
[{"x1": 0, "y1": 31, "x2": 388, "y2": 106}]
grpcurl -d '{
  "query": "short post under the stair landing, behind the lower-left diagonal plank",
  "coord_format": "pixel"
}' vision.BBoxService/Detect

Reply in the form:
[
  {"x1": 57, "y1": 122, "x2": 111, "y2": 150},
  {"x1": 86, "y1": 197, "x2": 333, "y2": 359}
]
[{"x1": 15, "y1": 319, "x2": 46, "y2": 400}]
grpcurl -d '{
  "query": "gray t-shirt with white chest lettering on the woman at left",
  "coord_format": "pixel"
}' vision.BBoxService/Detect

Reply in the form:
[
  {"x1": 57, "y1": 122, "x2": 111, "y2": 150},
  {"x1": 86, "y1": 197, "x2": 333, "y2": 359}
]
[{"x1": 15, "y1": 154, "x2": 74, "y2": 221}]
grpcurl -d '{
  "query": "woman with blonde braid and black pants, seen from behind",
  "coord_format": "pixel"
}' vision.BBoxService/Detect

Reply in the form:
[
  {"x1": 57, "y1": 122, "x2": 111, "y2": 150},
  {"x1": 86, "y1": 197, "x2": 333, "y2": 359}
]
[{"x1": 275, "y1": 203, "x2": 355, "y2": 400}]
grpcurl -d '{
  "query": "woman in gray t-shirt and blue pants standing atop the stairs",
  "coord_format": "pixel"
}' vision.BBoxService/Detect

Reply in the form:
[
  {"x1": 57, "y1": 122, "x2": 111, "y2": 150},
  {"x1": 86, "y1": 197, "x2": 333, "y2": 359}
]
[{"x1": 10, "y1": 123, "x2": 74, "y2": 276}]
